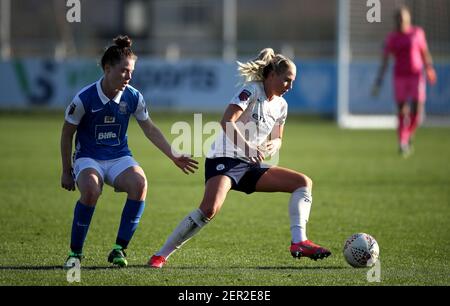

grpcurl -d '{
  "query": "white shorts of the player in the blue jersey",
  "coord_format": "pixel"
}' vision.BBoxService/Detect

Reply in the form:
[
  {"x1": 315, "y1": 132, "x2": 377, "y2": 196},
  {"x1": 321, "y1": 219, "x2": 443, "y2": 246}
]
[{"x1": 73, "y1": 156, "x2": 139, "y2": 187}]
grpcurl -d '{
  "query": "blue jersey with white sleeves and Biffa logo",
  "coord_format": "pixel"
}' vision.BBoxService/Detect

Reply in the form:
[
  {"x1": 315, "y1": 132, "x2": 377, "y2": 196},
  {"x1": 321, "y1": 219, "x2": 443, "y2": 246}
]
[{"x1": 65, "y1": 79, "x2": 148, "y2": 160}]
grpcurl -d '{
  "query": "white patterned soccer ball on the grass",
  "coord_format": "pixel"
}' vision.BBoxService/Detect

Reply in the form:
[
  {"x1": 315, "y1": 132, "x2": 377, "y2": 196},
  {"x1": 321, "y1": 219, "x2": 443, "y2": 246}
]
[{"x1": 344, "y1": 233, "x2": 380, "y2": 268}]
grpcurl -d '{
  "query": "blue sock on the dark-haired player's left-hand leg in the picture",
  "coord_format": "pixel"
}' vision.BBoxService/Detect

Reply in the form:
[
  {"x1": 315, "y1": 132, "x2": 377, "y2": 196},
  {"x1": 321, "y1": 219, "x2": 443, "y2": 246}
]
[{"x1": 70, "y1": 201, "x2": 95, "y2": 254}]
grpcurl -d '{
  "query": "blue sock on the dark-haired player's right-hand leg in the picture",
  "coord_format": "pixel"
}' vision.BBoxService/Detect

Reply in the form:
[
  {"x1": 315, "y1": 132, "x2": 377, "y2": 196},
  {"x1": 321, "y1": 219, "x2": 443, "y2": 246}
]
[{"x1": 116, "y1": 199, "x2": 145, "y2": 249}]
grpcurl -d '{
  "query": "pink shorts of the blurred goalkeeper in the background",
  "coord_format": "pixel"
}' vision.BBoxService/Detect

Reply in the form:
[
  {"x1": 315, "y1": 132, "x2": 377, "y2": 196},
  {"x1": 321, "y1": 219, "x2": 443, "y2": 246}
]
[{"x1": 394, "y1": 74, "x2": 426, "y2": 103}]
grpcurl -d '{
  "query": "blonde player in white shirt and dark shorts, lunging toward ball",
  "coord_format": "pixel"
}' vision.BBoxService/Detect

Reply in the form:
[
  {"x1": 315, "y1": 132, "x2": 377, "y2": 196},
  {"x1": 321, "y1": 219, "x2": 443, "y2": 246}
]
[{"x1": 148, "y1": 48, "x2": 331, "y2": 268}]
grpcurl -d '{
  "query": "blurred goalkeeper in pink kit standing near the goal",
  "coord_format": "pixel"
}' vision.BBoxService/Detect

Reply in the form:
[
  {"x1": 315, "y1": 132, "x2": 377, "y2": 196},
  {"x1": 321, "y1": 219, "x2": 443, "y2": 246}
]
[{"x1": 373, "y1": 7, "x2": 437, "y2": 156}]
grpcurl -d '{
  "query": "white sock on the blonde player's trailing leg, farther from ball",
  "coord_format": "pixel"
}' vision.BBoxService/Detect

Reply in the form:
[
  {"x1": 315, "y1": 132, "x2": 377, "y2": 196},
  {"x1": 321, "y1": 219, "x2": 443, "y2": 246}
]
[{"x1": 155, "y1": 209, "x2": 209, "y2": 259}]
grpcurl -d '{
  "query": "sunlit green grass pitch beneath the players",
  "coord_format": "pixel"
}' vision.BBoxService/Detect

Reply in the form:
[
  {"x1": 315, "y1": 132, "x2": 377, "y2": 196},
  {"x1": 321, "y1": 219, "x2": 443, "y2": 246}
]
[{"x1": 0, "y1": 113, "x2": 450, "y2": 286}]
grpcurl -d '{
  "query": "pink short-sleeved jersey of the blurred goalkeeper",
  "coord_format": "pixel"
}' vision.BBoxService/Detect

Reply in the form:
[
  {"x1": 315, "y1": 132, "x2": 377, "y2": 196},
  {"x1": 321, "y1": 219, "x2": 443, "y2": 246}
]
[{"x1": 384, "y1": 26, "x2": 427, "y2": 76}]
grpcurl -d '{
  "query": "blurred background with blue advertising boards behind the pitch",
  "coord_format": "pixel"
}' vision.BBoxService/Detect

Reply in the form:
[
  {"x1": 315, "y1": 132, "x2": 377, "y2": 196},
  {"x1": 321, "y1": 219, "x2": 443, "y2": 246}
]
[{"x1": 0, "y1": 0, "x2": 450, "y2": 122}]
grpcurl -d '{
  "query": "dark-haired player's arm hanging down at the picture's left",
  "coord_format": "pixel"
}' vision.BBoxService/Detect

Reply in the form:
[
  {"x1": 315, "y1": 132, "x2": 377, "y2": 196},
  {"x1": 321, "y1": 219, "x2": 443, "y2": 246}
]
[{"x1": 61, "y1": 121, "x2": 77, "y2": 191}]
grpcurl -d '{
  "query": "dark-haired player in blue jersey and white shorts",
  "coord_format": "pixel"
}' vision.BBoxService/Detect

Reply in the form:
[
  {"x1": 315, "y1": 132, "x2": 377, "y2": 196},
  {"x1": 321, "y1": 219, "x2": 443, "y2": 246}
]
[{"x1": 61, "y1": 36, "x2": 197, "y2": 268}]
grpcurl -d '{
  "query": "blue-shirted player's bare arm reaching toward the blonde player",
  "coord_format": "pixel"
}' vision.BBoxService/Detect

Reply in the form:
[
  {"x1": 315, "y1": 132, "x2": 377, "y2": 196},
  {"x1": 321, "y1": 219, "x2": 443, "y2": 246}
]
[{"x1": 138, "y1": 118, "x2": 198, "y2": 174}]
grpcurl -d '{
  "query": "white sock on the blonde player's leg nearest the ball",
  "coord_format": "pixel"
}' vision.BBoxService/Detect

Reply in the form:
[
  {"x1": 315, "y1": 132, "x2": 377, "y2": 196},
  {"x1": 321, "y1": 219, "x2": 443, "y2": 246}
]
[{"x1": 289, "y1": 187, "x2": 312, "y2": 243}]
